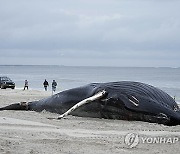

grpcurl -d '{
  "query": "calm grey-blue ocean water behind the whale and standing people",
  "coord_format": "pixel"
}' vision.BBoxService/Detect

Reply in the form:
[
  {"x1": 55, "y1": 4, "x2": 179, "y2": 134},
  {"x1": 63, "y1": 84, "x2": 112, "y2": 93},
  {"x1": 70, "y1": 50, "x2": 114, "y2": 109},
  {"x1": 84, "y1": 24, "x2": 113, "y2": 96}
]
[{"x1": 0, "y1": 65, "x2": 180, "y2": 101}]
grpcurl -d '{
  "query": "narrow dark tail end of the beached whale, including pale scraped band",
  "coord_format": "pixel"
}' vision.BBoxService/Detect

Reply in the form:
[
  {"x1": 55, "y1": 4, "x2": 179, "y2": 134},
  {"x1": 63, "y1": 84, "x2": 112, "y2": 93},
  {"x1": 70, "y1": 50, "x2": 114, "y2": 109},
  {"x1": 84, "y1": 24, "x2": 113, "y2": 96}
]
[{"x1": 0, "y1": 102, "x2": 28, "y2": 111}]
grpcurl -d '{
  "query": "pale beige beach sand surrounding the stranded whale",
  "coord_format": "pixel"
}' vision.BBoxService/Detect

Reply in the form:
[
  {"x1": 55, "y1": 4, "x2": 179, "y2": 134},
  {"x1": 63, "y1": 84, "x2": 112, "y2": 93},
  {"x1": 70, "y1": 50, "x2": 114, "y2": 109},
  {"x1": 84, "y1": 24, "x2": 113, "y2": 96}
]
[{"x1": 0, "y1": 89, "x2": 180, "y2": 154}]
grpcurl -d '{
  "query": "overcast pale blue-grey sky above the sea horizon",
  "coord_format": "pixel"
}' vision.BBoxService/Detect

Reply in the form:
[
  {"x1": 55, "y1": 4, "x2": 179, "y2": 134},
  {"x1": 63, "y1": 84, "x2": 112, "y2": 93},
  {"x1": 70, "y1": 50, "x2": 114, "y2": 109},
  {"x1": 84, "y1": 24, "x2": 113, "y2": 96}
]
[{"x1": 0, "y1": 0, "x2": 180, "y2": 67}]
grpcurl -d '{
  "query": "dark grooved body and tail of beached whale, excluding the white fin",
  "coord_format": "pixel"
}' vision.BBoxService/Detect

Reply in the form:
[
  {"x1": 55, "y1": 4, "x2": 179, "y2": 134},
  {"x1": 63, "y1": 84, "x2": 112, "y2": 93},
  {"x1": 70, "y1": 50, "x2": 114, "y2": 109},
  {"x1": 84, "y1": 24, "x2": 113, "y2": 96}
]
[{"x1": 0, "y1": 81, "x2": 180, "y2": 125}]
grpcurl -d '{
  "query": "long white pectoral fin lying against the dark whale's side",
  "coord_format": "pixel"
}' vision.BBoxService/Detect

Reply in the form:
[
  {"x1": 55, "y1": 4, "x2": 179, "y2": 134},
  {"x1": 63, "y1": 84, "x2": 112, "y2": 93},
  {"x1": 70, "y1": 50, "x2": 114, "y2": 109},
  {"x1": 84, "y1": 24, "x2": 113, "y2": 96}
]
[{"x1": 57, "y1": 90, "x2": 107, "y2": 119}]
